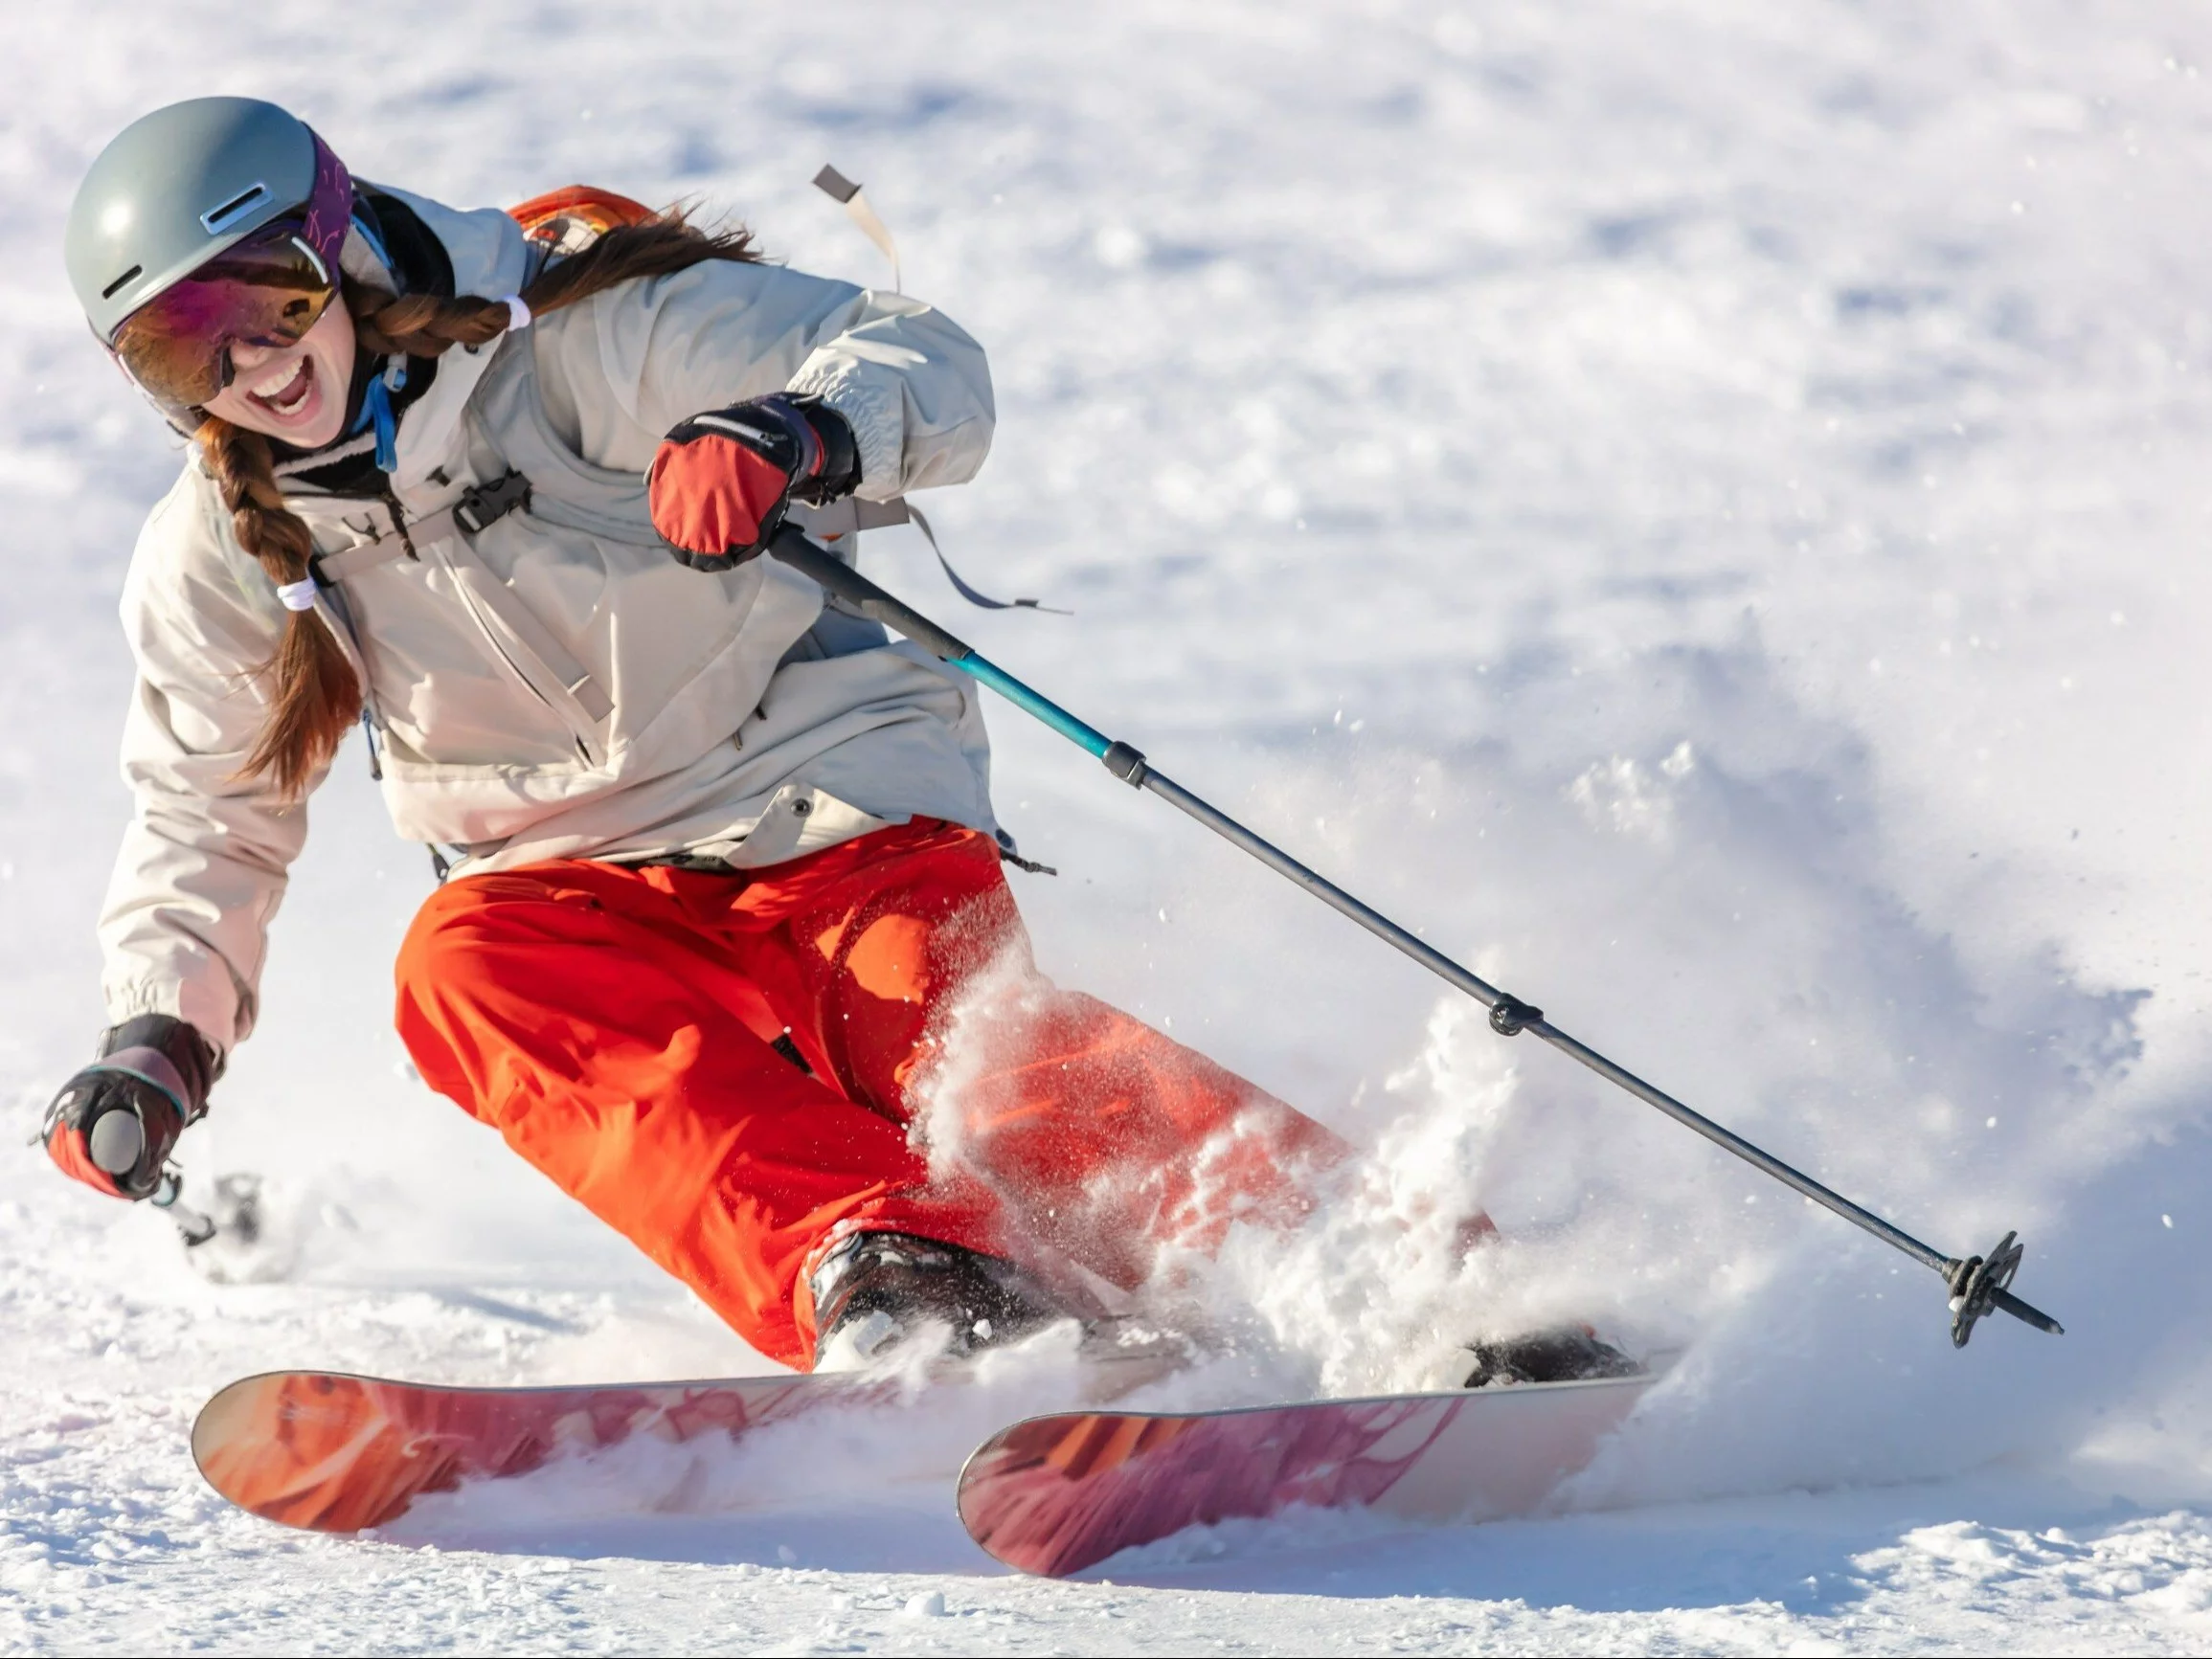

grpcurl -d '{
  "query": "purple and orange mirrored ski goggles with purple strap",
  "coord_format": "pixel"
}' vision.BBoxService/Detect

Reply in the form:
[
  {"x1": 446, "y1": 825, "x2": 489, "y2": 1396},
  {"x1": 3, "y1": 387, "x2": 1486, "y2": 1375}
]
[{"x1": 108, "y1": 140, "x2": 354, "y2": 422}]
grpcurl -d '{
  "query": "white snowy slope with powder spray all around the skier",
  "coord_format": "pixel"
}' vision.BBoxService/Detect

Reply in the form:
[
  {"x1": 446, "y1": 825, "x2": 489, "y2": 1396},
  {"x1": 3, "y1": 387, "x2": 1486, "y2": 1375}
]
[{"x1": 0, "y1": 0, "x2": 2212, "y2": 1652}]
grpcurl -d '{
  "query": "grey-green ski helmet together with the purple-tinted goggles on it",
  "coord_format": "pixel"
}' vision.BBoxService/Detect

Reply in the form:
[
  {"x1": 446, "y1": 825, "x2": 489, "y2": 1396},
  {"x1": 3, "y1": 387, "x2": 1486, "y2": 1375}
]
[{"x1": 62, "y1": 98, "x2": 354, "y2": 415}]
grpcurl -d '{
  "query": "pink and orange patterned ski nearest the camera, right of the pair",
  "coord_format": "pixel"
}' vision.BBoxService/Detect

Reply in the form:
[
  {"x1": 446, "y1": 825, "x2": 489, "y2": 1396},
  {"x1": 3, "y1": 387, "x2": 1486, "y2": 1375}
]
[{"x1": 960, "y1": 1376, "x2": 1653, "y2": 1578}]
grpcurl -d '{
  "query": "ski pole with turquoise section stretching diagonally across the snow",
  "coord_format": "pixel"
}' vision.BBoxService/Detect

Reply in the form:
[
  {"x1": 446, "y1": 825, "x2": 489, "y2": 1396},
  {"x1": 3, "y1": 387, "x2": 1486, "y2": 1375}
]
[{"x1": 770, "y1": 525, "x2": 2066, "y2": 1347}]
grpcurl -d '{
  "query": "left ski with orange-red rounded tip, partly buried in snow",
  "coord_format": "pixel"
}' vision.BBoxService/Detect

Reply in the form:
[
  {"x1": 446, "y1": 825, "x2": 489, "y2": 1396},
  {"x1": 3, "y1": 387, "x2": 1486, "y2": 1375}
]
[{"x1": 192, "y1": 1372, "x2": 880, "y2": 1533}]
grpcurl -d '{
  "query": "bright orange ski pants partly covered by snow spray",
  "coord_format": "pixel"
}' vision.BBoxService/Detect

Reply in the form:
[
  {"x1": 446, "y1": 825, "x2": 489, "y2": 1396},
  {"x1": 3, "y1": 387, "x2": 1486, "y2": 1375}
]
[{"x1": 398, "y1": 818, "x2": 1347, "y2": 1367}]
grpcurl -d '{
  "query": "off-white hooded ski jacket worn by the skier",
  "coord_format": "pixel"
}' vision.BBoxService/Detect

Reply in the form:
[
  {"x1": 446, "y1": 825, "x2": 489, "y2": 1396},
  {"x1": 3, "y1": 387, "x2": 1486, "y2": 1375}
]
[{"x1": 100, "y1": 197, "x2": 996, "y2": 1051}]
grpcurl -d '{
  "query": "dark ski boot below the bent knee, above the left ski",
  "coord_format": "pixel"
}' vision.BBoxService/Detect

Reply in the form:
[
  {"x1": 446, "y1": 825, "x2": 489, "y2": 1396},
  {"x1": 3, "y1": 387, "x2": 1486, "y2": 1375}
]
[{"x1": 807, "y1": 1232, "x2": 1072, "y2": 1372}]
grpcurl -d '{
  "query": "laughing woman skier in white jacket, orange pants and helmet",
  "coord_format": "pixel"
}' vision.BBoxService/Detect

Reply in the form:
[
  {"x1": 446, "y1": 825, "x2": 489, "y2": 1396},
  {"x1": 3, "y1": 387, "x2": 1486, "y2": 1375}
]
[{"x1": 44, "y1": 98, "x2": 1343, "y2": 1367}]
